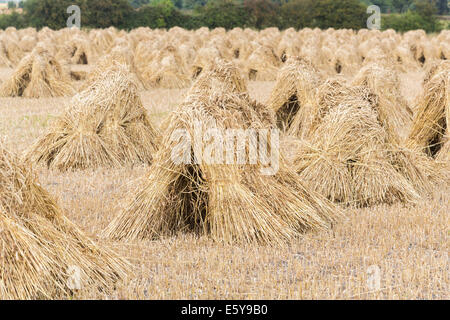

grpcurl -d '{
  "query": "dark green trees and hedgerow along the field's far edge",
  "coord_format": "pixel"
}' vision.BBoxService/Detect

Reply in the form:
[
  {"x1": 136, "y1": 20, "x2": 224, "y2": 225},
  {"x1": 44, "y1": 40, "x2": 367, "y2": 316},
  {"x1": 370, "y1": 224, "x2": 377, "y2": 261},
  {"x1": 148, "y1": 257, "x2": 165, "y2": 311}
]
[{"x1": 0, "y1": 0, "x2": 448, "y2": 32}]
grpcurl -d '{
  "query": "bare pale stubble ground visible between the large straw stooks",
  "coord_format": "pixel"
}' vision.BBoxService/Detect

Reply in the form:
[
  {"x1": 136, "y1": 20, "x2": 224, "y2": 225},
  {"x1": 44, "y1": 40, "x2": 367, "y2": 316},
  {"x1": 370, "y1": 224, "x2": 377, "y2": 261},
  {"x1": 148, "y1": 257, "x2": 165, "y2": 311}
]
[{"x1": 0, "y1": 68, "x2": 450, "y2": 299}]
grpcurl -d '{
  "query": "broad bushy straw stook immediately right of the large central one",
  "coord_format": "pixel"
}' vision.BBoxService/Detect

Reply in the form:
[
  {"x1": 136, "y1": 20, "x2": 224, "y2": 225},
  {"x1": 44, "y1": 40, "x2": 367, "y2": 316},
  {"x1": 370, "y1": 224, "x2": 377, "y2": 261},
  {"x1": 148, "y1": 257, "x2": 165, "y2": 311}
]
[{"x1": 288, "y1": 80, "x2": 438, "y2": 207}]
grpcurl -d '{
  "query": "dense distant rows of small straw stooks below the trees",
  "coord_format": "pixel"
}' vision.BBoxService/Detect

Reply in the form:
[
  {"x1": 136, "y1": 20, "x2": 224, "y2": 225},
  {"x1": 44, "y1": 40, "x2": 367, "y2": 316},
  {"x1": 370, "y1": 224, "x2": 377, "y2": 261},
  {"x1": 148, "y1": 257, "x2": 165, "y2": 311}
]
[{"x1": 0, "y1": 28, "x2": 450, "y2": 97}]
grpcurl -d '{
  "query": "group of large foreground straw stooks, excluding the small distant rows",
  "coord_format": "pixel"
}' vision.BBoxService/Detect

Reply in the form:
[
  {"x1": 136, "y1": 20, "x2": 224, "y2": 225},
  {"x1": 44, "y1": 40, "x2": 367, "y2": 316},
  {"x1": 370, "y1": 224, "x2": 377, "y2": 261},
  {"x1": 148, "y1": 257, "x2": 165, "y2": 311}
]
[{"x1": 0, "y1": 48, "x2": 450, "y2": 298}]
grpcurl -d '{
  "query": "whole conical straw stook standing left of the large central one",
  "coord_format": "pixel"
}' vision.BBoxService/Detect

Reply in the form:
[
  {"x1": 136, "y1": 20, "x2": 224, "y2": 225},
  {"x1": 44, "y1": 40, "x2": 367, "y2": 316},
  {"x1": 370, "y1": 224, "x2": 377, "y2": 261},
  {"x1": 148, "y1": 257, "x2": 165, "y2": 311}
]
[{"x1": 28, "y1": 64, "x2": 157, "y2": 171}]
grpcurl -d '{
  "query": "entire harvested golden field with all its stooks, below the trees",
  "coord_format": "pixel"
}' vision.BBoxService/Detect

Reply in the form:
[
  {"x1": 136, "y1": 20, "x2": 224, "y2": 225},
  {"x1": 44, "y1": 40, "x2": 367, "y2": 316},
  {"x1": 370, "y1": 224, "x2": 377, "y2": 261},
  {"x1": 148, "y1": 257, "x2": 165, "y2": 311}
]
[{"x1": 0, "y1": 28, "x2": 450, "y2": 299}]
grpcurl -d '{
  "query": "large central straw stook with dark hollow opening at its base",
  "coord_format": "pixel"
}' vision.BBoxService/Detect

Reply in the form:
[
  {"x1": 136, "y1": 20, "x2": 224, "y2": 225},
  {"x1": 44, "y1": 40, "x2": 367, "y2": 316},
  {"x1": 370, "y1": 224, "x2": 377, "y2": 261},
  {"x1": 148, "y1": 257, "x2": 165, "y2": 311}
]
[{"x1": 104, "y1": 61, "x2": 340, "y2": 244}]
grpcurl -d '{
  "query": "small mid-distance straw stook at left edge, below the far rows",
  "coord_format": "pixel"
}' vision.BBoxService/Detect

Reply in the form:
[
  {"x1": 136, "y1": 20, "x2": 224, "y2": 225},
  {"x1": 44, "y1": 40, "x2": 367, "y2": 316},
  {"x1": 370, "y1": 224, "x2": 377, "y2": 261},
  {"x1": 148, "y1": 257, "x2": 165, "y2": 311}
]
[{"x1": 0, "y1": 46, "x2": 73, "y2": 98}]
